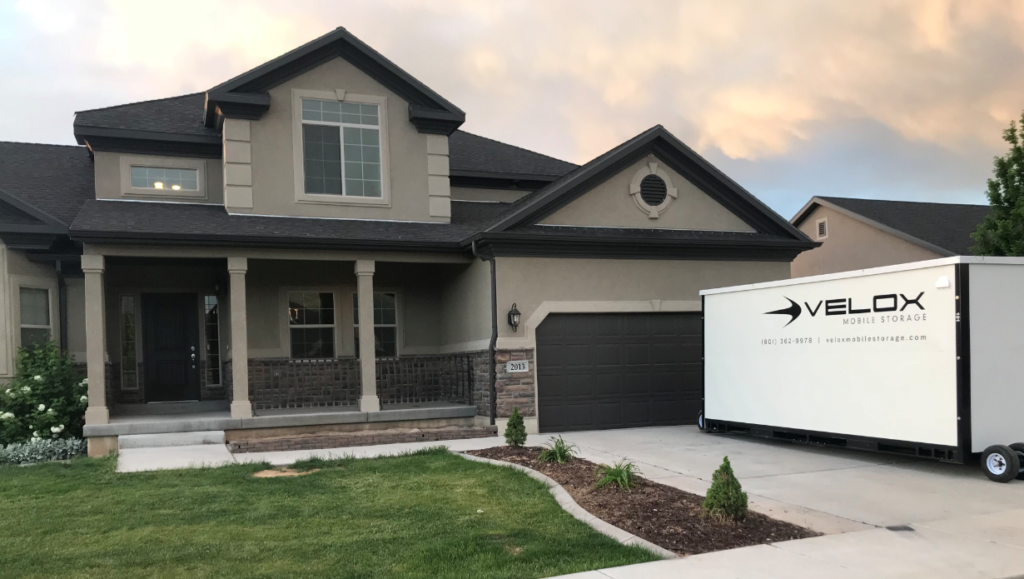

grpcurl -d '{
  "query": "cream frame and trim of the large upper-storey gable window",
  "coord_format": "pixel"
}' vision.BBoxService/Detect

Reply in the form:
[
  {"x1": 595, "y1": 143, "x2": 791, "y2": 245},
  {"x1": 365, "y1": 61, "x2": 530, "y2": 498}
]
[{"x1": 292, "y1": 88, "x2": 391, "y2": 207}]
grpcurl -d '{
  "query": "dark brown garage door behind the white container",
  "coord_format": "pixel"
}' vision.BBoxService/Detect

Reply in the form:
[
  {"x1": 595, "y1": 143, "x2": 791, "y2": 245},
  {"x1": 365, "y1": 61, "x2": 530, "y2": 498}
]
[{"x1": 537, "y1": 314, "x2": 703, "y2": 432}]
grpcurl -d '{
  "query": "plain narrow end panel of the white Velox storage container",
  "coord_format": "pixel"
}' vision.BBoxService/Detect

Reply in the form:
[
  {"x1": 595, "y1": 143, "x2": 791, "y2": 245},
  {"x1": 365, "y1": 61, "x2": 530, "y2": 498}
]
[{"x1": 970, "y1": 263, "x2": 1024, "y2": 452}]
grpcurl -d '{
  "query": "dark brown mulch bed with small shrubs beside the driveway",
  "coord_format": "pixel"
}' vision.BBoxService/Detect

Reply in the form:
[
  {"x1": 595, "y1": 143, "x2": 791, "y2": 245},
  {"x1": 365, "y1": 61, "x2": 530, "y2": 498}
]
[{"x1": 468, "y1": 446, "x2": 818, "y2": 555}]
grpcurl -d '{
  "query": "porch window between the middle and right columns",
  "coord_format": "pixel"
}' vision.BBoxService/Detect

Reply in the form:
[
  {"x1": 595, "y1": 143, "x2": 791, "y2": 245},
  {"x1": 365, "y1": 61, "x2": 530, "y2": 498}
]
[{"x1": 288, "y1": 291, "x2": 335, "y2": 359}]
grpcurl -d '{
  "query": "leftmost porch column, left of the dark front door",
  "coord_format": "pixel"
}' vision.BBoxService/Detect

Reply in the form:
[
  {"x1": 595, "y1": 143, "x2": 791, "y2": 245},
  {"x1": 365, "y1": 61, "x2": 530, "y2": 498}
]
[{"x1": 82, "y1": 255, "x2": 111, "y2": 424}]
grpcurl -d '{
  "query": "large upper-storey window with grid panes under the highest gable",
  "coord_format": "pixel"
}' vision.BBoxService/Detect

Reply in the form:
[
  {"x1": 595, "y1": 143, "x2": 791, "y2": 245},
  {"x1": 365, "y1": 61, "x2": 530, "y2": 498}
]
[{"x1": 302, "y1": 98, "x2": 383, "y2": 199}]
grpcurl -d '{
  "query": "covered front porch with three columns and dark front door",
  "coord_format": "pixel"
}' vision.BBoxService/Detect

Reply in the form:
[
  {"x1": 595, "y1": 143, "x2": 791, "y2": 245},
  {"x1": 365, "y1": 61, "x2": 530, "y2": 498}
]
[{"x1": 82, "y1": 246, "x2": 489, "y2": 455}]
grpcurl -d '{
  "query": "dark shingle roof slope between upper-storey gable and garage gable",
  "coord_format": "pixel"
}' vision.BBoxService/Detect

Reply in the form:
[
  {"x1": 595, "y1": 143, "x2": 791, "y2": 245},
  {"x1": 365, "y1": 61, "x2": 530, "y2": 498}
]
[{"x1": 449, "y1": 130, "x2": 577, "y2": 177}]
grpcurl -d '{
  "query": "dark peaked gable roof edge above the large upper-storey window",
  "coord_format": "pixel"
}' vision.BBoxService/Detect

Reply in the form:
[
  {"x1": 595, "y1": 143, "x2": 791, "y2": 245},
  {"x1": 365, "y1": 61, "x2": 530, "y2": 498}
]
[{"x1": 205, "y1": 27, "x2": 466, "y2": 134}]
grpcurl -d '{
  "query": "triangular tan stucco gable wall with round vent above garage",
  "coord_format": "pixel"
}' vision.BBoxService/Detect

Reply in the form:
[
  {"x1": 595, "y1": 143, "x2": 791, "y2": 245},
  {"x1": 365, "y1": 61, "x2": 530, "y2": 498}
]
[{"x1": 541, "y1": 155, "x2": 754, "y2": 232}]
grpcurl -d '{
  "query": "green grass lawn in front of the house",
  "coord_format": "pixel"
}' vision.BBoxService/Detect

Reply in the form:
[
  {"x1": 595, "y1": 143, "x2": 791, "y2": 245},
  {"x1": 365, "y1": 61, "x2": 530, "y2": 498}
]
[{"x1": 0, "y1": 444, "x2": 656, "y2": 579}]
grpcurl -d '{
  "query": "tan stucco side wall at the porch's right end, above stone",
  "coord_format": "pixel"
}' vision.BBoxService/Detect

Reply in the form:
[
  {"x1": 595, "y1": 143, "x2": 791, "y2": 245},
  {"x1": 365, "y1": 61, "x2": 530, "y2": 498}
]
[{"x1": 441, "y1": 259, "x2": 490, "y2": 351}]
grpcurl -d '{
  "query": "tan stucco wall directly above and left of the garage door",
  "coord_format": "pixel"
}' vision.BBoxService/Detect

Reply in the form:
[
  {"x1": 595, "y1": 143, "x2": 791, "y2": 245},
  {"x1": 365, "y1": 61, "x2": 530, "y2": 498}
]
[{"x1": 497, "y1": 257, "x2": 790, "y2": 348}]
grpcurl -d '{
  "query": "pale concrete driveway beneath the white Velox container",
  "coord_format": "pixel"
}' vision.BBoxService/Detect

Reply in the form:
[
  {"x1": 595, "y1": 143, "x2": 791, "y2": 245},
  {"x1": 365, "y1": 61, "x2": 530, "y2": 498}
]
[{"x1": 548, "y1": 426, "x2": 1024, "y2": 579}]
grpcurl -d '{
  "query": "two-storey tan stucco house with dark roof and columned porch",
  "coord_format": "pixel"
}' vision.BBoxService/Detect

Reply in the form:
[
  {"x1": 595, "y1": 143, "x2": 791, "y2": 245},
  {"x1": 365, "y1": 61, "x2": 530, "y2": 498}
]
[{"x1": 0, "y1": 29, "x2": 815, "y2": 455}]
